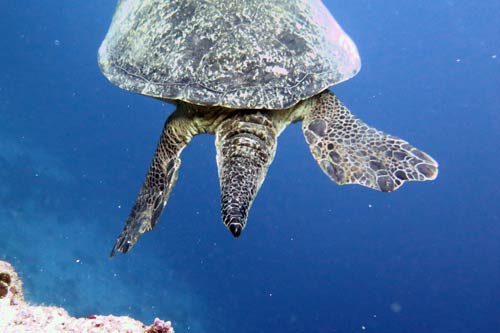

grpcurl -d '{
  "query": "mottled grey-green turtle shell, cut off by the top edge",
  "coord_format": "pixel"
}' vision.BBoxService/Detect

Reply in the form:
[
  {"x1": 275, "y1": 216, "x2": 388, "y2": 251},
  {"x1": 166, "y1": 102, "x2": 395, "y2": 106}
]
[{"x1": 99, "y1": 0, "x2": 361, "y2": 109}]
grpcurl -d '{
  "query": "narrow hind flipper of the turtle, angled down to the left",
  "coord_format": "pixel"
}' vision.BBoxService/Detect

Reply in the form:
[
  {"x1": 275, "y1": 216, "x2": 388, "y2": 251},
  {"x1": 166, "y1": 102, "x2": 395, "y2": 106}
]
[{"x1": 111, "y1": 108, "x2": 196, "y2": 256}]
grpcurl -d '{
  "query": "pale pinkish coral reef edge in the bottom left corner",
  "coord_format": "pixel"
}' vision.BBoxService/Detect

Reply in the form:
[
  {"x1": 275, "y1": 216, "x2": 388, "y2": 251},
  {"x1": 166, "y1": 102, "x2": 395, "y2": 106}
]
[{"x1": 0, "y1": 260, "x2": 174, "y2": 333}]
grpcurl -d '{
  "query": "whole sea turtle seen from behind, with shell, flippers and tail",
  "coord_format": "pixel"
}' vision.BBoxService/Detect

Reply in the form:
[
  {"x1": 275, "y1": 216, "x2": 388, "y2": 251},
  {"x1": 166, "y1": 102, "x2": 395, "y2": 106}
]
[{"x1": 99, "y1": 0, "x2": 438, "y2": 256}]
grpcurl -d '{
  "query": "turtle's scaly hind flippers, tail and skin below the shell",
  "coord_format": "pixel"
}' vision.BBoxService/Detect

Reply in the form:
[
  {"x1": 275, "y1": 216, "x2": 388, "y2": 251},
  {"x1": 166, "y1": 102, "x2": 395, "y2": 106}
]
[{"x1": 111, "y1": 90, "x2": 438, "y2": 256}]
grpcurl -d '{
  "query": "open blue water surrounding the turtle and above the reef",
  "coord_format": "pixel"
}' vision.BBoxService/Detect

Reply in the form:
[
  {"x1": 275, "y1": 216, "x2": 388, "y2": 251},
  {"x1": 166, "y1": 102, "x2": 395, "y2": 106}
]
[{"x1": 0, "y1": 0, "x2": 500, "y2": 333}]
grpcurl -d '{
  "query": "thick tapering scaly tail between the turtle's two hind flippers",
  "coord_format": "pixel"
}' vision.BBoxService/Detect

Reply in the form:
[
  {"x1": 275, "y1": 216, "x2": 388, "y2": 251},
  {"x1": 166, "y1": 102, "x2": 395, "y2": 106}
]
[{"x1": 215, "y1": 110, "x2": 277, "y2": 237}]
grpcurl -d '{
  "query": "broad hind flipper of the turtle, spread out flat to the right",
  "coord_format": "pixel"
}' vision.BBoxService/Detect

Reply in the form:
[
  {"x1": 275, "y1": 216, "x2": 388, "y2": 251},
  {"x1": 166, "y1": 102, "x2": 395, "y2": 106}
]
[{"x1": 302, "y1": 90, "x2": 438, "y2": 192}]
